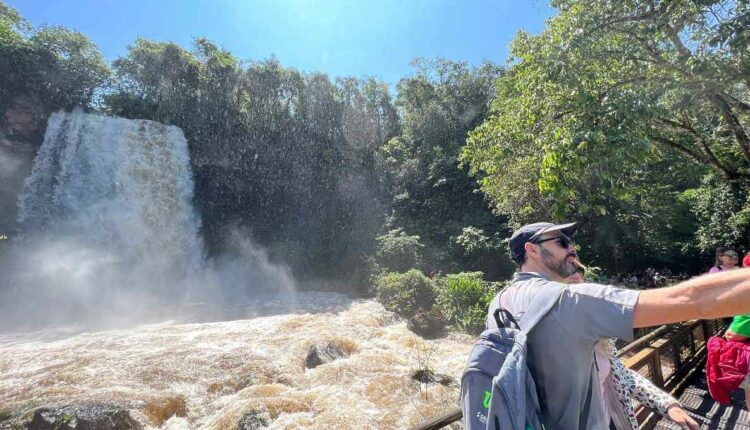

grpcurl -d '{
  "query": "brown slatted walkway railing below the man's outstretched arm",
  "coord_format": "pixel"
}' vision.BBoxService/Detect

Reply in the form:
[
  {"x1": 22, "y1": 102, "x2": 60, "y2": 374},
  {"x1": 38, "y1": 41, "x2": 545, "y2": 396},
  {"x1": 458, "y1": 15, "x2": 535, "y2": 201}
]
[{"x1": 412, "y1": 320, "x2": 726, "y2": 430}]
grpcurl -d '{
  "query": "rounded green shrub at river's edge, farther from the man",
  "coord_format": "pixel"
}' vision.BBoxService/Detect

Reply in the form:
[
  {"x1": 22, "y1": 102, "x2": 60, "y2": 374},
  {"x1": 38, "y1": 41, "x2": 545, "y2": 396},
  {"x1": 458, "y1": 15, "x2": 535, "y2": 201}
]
[{"x1": 375, "y1": 269, "x2": 435, "y2": 318}]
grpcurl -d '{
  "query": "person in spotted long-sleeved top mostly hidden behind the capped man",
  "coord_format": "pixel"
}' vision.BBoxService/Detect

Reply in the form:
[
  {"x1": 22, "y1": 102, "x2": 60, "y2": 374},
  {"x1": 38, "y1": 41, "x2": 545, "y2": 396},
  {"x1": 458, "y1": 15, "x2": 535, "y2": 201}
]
[{"x1": 565, "y1": 260, "x2": 700, "y2": 430}]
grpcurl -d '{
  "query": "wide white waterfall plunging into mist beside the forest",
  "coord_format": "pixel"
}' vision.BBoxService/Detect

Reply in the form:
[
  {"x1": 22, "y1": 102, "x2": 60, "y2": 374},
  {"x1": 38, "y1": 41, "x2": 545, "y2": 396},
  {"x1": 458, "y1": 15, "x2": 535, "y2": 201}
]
[{"x1": 16, "y1": 111, "x2": 203, "y2": 306}]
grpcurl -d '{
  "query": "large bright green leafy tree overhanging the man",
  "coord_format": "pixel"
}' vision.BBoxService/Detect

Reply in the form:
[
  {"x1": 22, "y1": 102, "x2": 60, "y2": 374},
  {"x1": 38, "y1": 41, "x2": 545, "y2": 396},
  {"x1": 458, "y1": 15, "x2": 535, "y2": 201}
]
[{"x1": 462, "y1": 0, "x2": 750, "y2": 263}]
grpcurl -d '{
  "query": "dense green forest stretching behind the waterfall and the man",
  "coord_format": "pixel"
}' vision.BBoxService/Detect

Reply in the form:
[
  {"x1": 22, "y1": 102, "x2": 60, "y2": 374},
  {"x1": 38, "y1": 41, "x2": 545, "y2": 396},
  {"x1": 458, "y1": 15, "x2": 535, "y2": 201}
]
[{"x1": 0, "y1": 0, "x2": 750, "y2": 292}]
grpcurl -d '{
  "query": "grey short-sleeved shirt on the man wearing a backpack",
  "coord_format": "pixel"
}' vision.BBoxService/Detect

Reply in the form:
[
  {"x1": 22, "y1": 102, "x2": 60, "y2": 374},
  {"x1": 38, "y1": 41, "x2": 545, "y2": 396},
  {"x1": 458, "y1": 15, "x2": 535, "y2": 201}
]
[{"x1": 487, "y1": 272, "x2": 639, "y2": 430}]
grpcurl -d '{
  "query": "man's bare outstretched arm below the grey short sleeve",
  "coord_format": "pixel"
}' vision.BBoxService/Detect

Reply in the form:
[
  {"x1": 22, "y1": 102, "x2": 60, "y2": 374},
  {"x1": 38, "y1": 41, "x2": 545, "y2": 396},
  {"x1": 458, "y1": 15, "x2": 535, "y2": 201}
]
[{"x1": 633, "y1": 268, "x2": 750, "y2": 328}]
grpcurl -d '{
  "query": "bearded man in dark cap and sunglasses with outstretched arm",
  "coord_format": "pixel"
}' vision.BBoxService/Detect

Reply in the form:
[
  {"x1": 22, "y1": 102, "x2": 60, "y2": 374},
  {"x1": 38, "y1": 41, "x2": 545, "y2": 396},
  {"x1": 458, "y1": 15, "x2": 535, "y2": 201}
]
[{"x1": 487, "y1": 223, "x2": 750, "y2": 430}]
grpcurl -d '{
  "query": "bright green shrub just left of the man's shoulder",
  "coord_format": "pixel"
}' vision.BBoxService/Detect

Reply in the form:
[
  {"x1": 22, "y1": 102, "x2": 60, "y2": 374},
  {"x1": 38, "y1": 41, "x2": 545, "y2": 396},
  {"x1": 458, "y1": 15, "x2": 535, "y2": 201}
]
[{"x1": 437, "y1": 272, "x2": 500, "y2": 334}]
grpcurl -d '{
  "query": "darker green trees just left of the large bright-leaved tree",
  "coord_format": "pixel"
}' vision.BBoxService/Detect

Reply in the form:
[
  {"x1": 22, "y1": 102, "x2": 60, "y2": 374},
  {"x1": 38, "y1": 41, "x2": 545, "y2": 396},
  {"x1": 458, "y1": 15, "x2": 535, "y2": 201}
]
[{"x1": 381, "y1": 60, "x2": 509, "y2": 273}]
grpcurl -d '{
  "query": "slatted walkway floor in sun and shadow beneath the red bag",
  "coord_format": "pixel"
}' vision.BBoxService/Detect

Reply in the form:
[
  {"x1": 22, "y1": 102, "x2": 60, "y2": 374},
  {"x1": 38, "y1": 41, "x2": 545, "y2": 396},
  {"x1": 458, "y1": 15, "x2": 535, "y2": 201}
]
[{"x1": 655, "y1": 371, "x2": 750, "y2": 430}]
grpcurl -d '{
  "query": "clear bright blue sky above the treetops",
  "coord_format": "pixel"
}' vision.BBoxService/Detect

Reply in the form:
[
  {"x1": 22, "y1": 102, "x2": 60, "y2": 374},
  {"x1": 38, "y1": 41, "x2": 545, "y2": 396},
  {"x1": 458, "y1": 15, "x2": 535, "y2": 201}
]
[{"x1": 4, "y1": 0, "x2": 554, "y2": 84}]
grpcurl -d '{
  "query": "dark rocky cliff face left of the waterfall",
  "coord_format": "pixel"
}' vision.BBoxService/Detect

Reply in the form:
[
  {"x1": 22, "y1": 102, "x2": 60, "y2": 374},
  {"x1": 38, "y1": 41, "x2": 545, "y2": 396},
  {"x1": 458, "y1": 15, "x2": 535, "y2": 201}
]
[{"x1": 0, "y1": 98, "x2": 48, "y2": 235}]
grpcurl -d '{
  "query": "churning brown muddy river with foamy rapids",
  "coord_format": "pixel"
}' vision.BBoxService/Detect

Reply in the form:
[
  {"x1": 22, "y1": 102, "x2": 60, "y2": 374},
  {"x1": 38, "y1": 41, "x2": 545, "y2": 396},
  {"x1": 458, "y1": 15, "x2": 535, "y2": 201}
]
[{"x1": 0, "y1": 293, "x2": 473, "y2": 430}]
